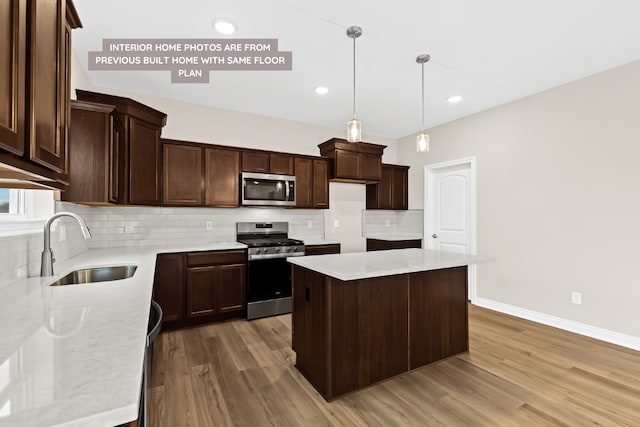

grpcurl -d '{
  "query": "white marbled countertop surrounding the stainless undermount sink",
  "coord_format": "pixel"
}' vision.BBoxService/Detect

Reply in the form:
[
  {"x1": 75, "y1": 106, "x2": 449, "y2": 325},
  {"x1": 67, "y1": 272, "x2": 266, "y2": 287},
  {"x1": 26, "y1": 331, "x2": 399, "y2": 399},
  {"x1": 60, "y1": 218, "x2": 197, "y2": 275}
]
[{"x1": 0, "y1": 242, "x2": 246, "y2": 427}]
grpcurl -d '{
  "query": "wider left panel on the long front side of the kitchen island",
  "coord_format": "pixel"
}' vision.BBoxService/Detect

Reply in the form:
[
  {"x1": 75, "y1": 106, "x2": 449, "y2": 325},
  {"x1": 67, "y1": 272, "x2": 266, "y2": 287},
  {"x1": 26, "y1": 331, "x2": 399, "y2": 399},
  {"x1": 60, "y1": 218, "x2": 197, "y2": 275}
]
[{"x1": 328, "y1": 275, "x2": 408, "y2": 398}]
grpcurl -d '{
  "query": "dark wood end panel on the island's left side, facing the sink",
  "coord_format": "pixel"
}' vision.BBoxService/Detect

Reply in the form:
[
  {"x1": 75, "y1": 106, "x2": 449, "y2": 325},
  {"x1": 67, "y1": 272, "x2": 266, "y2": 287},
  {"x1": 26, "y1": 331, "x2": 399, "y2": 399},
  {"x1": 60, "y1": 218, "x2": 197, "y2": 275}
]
[{"x1": 292, "y1": 268, "x2": 327, "y2": 395}]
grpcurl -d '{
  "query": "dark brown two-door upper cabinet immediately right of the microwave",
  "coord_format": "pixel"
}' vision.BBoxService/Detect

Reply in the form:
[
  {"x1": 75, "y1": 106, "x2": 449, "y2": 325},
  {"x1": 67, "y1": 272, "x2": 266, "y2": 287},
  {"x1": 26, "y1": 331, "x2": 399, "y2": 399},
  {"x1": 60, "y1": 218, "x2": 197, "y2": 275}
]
[{"x1": 295, "y1": 157, "x2": 329, "y2": 209}]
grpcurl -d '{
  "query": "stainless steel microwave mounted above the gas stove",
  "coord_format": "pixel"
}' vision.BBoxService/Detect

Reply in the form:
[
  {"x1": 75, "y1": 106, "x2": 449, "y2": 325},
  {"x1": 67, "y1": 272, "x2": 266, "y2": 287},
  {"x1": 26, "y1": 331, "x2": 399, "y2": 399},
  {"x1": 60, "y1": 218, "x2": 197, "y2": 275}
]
[{"x1": 240, "y1": 172, "x2": 296, "y2": 206}]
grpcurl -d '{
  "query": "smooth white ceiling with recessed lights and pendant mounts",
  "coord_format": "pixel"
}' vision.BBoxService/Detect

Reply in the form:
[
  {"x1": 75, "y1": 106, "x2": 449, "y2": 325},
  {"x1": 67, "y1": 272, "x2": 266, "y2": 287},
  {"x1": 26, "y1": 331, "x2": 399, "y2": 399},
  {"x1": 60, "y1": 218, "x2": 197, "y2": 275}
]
[{"x1": 73, "y1": 0, "x2": 640, "y2": 138}]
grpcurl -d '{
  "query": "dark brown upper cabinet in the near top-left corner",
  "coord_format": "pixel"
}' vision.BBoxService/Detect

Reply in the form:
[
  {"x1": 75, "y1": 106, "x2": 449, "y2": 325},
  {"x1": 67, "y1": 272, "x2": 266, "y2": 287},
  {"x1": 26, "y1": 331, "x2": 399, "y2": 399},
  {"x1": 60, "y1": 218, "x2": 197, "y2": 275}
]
[{"x1": 0, "y1": 0, "x2": 82, "y2": 184}]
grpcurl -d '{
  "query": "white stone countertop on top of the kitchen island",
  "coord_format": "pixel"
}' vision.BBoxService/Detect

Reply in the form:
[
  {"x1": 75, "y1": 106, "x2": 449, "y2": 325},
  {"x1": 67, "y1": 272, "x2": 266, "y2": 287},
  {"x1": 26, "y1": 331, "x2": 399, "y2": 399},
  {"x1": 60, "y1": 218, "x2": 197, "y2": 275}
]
[{"x1": 287, "y1": 249, "x2": 494, "y2": 281}]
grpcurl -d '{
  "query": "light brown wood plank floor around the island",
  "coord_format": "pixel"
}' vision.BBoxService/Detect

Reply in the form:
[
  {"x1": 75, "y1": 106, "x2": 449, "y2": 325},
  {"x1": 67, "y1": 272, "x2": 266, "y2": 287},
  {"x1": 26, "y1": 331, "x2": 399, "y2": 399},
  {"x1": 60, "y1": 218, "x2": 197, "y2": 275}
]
[{"x1": 149, "y1": 306, "x2": 640, "y2": 427}]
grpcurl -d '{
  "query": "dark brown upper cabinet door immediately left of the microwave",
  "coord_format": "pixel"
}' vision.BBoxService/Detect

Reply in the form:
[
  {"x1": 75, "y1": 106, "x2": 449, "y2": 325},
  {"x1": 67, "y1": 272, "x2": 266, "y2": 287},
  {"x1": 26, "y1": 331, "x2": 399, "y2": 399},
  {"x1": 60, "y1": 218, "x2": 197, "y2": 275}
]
[{"x1": 204, "y1": 148, "x2": 240, "y2": 207}]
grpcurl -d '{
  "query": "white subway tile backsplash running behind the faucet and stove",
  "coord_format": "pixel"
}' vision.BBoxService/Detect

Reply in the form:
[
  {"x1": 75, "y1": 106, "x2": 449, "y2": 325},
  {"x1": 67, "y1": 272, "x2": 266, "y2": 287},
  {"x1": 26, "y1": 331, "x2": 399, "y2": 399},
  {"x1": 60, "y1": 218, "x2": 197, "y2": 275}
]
[{"x1": 0, "y1": 202, "x2": 324, "y2": 288}]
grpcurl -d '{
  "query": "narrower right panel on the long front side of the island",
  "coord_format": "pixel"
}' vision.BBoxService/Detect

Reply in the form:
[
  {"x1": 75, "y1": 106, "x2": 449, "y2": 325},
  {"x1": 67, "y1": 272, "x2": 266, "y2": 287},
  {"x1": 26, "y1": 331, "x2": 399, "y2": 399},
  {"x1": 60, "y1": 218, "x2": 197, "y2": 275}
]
[{"x1": 409, "y1": 267, "x2": 469, "y2": 369}]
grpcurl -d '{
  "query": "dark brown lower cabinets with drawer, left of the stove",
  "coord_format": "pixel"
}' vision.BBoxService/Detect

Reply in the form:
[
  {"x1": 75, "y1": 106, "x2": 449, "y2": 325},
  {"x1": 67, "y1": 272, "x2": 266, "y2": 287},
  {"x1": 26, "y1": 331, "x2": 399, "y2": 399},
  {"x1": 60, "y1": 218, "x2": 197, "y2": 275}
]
[{"x1": 153, "y1": 250, "x2": 246, "y2": 329}]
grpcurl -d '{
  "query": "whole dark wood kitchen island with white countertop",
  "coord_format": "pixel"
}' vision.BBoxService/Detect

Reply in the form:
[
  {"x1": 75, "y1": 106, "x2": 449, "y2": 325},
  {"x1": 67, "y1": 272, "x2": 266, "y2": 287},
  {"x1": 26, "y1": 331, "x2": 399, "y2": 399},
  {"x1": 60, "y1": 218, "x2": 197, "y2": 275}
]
[{"x1": 288, "y1": 249, "x2": 490, "y2": 401}]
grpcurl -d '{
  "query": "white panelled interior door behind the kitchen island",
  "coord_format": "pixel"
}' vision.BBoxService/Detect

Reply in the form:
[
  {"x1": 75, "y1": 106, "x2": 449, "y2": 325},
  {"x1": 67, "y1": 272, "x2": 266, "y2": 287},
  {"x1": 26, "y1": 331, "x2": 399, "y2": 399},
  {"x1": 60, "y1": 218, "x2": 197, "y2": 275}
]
[{"x1": 424, "y1": 158, "x2": 476, "y2": 301}]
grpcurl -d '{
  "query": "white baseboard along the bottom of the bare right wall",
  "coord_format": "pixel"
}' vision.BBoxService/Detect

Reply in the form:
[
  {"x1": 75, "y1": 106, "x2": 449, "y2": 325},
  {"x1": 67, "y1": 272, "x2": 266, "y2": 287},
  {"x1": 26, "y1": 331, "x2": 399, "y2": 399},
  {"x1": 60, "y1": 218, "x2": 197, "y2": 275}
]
[{"x1": 473, "y1": 297, "x2": 640, "y2": 351}]
